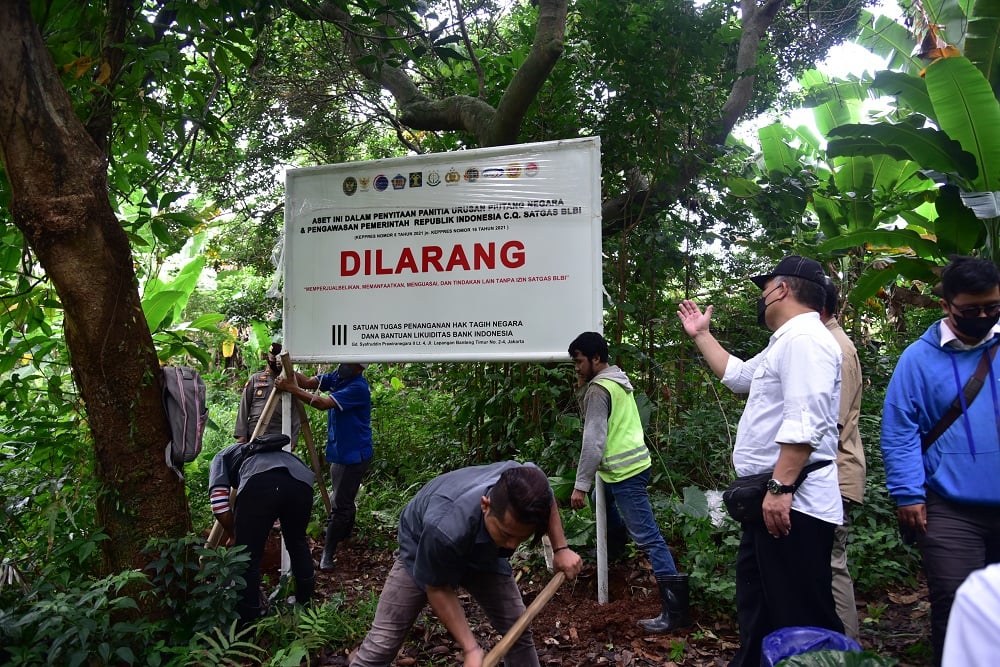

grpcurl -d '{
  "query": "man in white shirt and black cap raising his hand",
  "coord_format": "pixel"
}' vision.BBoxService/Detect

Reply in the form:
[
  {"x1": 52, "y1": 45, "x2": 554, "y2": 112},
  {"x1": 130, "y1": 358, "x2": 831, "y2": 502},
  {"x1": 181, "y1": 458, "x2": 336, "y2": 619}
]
[{"x1": 677, "y1": 255, "x2": 844, "y2": 667}]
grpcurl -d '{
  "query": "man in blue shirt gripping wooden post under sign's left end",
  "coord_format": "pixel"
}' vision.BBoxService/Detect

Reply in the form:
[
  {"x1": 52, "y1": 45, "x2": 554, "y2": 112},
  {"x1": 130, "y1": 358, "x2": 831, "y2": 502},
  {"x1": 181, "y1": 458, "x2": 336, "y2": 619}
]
[{"x1": 274, "y1": 363, "x2": 374, "y2": 572}]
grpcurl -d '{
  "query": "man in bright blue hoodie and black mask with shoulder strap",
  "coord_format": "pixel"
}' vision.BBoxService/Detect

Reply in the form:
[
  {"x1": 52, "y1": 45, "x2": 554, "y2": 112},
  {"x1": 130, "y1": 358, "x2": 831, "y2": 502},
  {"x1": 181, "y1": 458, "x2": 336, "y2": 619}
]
[{"x1": 882, "y1": 257, "x2": 1000, "y2": 664}]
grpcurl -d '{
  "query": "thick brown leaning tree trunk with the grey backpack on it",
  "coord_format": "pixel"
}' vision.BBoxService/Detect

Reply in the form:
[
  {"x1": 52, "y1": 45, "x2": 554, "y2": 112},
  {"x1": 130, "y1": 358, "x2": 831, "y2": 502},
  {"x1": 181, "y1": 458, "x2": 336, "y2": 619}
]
[{"x1": 0, "y1": 0, "x2": 191, "y2": 572}]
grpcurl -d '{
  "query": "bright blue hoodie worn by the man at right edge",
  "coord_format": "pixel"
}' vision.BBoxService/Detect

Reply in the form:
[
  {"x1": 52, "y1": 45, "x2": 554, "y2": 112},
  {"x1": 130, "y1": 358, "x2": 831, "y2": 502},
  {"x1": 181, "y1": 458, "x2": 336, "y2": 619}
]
[{"x1": 882, "y1": 321, "x2": 1000, "y2": 506}]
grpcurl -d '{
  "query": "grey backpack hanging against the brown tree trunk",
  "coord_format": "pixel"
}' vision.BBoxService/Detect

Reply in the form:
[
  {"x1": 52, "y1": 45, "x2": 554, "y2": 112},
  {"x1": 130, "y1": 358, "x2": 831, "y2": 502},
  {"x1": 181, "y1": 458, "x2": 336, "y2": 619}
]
[{"x1": 160, "y1": 366, "x2": 208, "y2": 479}]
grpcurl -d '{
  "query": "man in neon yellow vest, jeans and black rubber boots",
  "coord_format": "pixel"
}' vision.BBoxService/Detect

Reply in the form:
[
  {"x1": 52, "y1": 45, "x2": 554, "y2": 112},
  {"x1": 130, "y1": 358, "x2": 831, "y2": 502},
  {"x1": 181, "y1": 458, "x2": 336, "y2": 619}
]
[{"x1": 569, "y1": 331, "x2": 691, "y2": 634}]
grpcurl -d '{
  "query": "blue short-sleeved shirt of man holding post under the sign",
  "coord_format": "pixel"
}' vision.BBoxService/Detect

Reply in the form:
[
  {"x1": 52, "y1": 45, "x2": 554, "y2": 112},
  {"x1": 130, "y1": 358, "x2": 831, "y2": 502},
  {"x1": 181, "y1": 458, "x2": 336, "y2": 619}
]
[{"x1": 319, "y1": 371, "x2": 374, "y2": 465}]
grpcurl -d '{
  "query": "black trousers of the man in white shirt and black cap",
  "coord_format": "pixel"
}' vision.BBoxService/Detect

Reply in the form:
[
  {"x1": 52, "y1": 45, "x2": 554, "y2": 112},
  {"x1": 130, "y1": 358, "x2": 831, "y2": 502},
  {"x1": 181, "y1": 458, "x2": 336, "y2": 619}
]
[{"x1": 729, "y1": 510, "x2": 844, "y2": 667}]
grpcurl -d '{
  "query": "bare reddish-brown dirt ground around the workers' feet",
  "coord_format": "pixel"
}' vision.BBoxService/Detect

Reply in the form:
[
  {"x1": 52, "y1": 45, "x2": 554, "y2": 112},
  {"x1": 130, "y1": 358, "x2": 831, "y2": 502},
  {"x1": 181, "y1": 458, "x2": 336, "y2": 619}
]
[{"x1": 258, "y1": 537, "x2": 932, "y2": 667}]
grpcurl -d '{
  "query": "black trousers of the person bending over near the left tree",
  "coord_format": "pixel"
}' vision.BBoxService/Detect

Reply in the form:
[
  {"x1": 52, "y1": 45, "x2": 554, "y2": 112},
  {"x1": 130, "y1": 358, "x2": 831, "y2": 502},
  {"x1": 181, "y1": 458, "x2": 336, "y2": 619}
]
[{"x1": 233, "y1": 468, "x2": 315, "y2": 623}]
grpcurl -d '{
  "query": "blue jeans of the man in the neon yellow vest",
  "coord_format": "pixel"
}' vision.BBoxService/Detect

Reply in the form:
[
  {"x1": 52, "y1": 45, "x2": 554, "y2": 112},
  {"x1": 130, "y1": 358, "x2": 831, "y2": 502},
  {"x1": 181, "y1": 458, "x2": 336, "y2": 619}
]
[{"x1": 604, "y1": 468, "x2": 677, "y2": 577}]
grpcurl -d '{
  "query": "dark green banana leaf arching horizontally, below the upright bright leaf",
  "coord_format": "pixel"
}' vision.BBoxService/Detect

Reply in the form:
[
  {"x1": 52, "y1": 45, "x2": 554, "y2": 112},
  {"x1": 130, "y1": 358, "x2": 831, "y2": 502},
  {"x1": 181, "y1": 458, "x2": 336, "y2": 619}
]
[{"x1": 827, "y1": 123, "x2": 978, "y2": 180}]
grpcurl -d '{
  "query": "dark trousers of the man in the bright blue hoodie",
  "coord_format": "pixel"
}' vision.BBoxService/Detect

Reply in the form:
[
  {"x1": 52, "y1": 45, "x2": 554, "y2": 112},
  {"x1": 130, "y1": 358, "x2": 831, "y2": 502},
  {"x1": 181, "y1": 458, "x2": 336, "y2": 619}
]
[{"x1": 917, "y1": 490, "x2": 1000, "y2": 665}]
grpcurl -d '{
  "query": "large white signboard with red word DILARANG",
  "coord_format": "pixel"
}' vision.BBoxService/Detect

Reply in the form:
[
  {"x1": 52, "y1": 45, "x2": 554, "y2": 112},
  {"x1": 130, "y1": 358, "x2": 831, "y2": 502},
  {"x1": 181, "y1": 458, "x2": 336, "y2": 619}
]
[{"x1": 284, "y1": 137, "x2": 602, "y2": 362}]
